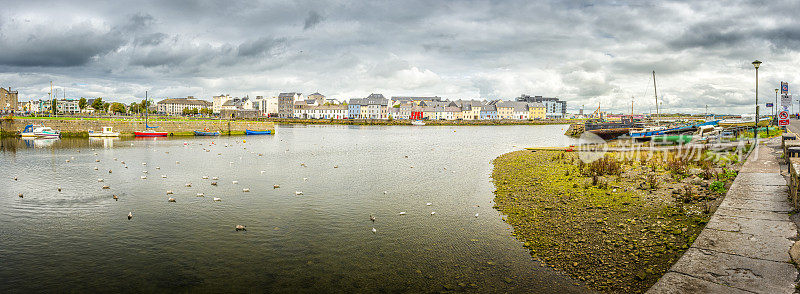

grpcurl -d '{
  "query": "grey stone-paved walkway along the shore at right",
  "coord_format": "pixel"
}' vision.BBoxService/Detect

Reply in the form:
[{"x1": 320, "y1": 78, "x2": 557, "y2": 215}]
[{"x1": 647, "y1": 139, "x2": 798, "y2": 293}]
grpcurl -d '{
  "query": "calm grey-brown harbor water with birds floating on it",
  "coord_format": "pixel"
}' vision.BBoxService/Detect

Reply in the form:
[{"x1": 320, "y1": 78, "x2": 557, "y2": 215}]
[{"x1": 0, "y1": 125, "x2": 586, "y2": 293}]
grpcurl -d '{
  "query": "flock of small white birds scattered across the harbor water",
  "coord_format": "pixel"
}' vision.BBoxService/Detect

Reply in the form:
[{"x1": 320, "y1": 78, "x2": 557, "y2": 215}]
[{"x1": 13, "y1": 140, "x2": 480, "y2": 233}]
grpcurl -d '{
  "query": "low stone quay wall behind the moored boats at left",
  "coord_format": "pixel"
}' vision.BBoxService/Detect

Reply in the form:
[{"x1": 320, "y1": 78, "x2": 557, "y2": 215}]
[{"x1": 0, "y1": 118, "x2": 275, "y2": 135}]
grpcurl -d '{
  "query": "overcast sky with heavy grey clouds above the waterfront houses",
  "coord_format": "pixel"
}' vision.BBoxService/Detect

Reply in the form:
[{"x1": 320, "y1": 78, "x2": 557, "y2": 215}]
[{"x1": 0, "y1": 0, "x2": 800, "y2": 113}]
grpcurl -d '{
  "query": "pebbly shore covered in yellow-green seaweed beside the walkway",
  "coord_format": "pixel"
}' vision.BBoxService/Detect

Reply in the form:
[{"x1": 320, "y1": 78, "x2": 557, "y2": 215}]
[{"x1": 492, "y1": 150, "x2": 741, "y2": 293}]
